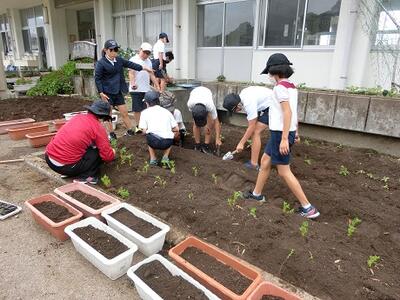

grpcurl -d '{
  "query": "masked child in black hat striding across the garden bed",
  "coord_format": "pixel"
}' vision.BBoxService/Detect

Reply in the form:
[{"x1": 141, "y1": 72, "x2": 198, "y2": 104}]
[{"x1": 243, "y1": 53, "x2": 319, "y2": 219}]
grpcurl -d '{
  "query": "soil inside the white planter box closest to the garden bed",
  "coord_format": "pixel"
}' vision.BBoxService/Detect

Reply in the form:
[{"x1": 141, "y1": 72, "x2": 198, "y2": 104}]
[{"x1": 110, "y1": 207, "x2": 160, "y2": 238}]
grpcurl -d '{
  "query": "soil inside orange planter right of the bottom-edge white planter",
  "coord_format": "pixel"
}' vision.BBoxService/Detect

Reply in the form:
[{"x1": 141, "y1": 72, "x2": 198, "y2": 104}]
[{"x1": 181, "y1": 247, "x2": 252, "y2": 295}]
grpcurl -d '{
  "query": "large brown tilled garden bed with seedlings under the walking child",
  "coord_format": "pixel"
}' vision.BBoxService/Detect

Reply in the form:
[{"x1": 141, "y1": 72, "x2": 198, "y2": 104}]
[{"x1": 102, "y1": 125, "x2": 400, "y2": 299}]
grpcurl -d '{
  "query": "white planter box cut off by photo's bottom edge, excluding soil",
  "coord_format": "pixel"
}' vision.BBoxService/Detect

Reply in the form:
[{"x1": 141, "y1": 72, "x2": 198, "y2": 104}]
[{"x1": 127, "y1": 254, "x2": 220, "y2": 300}]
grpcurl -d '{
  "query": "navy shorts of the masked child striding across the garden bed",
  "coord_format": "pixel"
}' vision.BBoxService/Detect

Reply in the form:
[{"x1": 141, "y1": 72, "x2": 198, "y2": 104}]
[{"x1": 264, "y1": 130, "x2": 296, "y2": 165}]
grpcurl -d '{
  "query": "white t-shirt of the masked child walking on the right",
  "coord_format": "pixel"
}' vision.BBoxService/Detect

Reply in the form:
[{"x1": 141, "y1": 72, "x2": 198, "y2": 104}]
[{"x1": 269, "y1": 80, "x2": 298, "y2": 131}]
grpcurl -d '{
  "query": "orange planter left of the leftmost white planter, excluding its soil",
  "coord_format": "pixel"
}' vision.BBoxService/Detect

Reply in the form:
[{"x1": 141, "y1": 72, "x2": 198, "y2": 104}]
[{"x1": 25, "y1": 194, "x2": 82, "y2": 241}]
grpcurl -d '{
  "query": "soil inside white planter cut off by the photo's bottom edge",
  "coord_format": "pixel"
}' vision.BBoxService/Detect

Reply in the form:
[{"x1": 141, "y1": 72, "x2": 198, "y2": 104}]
[{"x1": 135, "y1": 261, "x2": 208, "y2": 300}]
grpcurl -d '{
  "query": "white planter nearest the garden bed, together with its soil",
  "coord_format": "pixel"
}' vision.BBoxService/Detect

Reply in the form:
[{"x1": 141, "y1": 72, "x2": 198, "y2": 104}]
[{"x1": 101, "y1": 203, "x2": 170, "y2": 256}]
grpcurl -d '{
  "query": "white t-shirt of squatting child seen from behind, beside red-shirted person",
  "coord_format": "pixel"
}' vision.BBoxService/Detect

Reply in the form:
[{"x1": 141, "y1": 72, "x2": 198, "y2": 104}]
[{"x1": 139, "y1": 105, "x2": 178, "y2": 139}]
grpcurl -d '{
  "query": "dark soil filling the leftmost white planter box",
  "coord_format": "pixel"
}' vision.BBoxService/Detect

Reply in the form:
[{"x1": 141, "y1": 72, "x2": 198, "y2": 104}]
[{"x1": 74, "y1": 225, "x2": 128, "y2": 259}]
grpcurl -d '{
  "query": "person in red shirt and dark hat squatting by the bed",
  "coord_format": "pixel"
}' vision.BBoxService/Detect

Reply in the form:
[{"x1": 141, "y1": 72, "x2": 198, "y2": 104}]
[{"x1": 45, "y1": 100, "x2": 115, "y2": 184}]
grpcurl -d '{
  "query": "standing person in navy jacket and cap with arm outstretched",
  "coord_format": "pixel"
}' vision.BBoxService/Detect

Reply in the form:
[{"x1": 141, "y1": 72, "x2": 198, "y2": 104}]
[{"x1": 94, "y1": 40, "x2": 153, "y2": 139}]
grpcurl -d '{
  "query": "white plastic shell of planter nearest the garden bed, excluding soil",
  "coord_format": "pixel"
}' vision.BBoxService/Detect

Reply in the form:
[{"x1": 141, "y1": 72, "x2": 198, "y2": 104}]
[{"x1": 101, "y1": 203, "x2": 170, "y2": 256}]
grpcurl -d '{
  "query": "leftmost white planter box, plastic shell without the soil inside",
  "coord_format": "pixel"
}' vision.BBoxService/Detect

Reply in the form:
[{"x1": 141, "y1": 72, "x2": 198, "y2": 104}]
[{"x1": 65, "y1": 217, "x2": 137, "y2": 280}]
